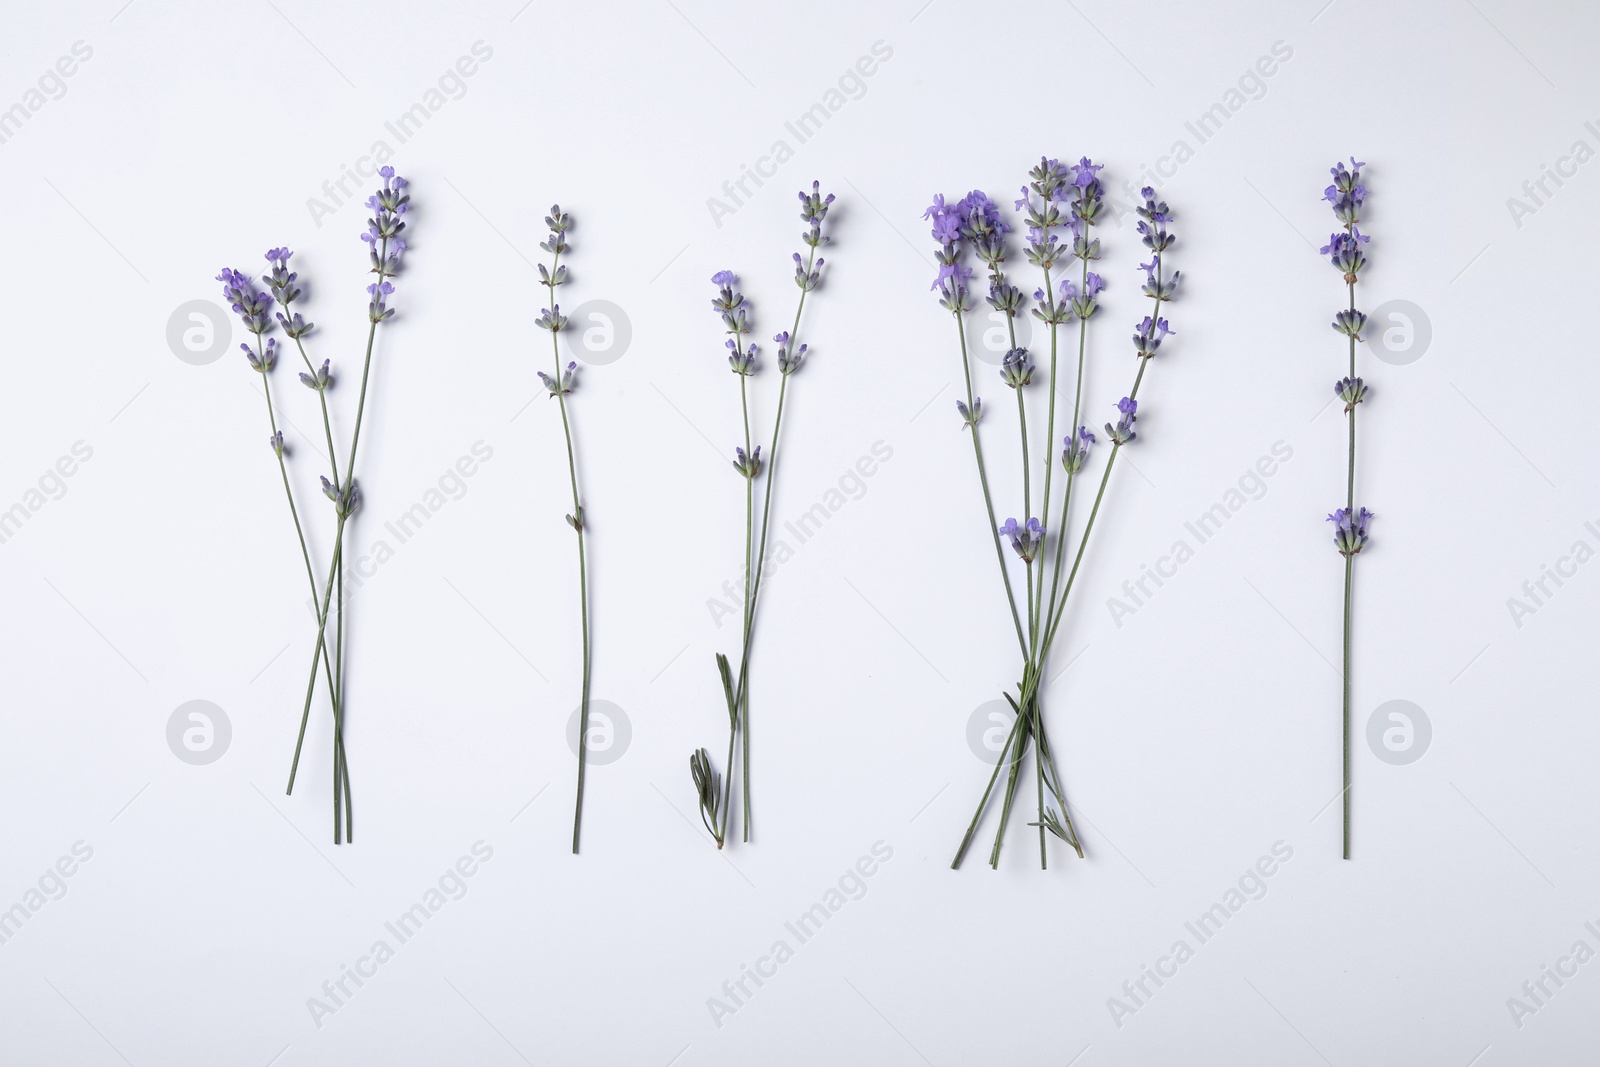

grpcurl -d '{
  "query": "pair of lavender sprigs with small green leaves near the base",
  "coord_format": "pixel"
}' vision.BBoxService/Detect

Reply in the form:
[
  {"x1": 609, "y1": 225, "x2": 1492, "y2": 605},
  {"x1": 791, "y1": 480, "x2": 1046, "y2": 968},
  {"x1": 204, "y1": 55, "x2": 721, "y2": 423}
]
[{"x1": 690, "y1": 182, "x2": 834, "y2": 849}]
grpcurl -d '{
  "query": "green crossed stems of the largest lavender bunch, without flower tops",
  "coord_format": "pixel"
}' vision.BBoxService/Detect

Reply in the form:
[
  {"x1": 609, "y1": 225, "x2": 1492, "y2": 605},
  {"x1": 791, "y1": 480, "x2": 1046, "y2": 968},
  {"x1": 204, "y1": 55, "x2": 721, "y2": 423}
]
[{"x1": 950, "y1": 239, "x2": 1162, "y2": 869}]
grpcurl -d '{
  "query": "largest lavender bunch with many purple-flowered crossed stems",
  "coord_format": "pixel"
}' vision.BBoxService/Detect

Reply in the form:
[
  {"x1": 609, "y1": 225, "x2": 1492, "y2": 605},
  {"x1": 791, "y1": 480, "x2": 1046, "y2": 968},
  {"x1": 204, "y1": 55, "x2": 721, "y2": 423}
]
[{"x1": 923, "y1": 157, "x2": 1178, "y2": 867}]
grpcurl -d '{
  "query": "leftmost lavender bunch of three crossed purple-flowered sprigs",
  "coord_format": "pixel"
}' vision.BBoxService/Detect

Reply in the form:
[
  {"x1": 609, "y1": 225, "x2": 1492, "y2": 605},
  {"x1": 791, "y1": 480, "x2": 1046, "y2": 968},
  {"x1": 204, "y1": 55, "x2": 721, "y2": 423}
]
[{"x1": 216, "y1": 166, "x2": 411, "y2": 845}]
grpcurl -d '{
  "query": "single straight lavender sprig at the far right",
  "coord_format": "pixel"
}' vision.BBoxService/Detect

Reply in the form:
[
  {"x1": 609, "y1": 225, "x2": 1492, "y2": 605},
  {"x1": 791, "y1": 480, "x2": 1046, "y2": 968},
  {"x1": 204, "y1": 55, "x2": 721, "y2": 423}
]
[{"x1": 1322, "y1": 155, "x2": 1373, "y2": 859}]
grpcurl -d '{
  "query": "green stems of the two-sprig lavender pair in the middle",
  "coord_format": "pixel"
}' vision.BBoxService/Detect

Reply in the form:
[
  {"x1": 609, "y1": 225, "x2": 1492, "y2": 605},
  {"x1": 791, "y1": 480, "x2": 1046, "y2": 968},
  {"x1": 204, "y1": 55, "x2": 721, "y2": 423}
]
[{"x1": 701, "y1": 245, "x2": 819, "y2": 848}]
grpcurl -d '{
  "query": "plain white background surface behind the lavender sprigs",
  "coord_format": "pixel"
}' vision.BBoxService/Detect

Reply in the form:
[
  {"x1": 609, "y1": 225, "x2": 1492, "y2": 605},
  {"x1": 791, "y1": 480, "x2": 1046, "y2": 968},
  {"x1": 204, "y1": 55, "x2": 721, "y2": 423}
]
[{"x1": 0, "y1": 0, "x2": 1600, "y2": 1067}]
